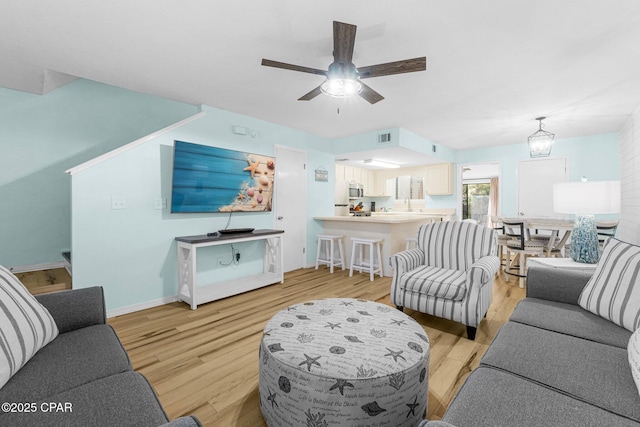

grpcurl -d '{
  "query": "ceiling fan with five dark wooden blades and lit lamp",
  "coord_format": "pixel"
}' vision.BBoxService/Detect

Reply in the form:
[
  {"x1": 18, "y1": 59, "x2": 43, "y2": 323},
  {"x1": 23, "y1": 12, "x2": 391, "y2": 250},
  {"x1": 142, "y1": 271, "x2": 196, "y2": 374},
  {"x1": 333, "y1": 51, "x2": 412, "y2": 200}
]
[{"x1": 262, "y1": 21, "x2": 427, "y2": 104}]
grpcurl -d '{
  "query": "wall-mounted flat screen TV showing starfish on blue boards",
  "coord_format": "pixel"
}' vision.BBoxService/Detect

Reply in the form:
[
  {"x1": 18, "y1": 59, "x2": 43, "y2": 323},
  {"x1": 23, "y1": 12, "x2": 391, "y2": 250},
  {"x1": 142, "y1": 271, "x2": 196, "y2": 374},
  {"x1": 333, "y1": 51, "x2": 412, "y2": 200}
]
[{"x1": 171, "y1": 141, "x2": 275, "y2": 213}]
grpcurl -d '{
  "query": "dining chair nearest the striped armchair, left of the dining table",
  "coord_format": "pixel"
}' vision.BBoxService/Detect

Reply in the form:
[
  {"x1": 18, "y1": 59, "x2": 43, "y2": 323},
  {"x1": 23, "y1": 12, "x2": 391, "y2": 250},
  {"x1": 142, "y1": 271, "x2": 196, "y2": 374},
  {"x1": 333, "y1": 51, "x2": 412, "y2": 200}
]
[{"x1": 502, "y1": 219, "x2": 546, "y2": 288}]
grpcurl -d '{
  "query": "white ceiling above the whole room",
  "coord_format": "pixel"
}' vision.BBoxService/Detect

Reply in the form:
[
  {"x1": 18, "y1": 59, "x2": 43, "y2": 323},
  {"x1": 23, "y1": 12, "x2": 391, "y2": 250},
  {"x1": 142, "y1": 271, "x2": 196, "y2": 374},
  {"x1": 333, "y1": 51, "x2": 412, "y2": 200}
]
[{"x1": 0, "y1": 0, "x2": 640, "y2": 155}]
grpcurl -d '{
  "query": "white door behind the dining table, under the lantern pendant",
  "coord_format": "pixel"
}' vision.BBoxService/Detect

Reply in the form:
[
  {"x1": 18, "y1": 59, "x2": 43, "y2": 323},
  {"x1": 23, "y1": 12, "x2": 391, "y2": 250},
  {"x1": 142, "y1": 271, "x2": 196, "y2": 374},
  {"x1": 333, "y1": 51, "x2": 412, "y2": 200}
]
[{"x1": 518, "y1": 158, "x2": 569, "y2": 218}]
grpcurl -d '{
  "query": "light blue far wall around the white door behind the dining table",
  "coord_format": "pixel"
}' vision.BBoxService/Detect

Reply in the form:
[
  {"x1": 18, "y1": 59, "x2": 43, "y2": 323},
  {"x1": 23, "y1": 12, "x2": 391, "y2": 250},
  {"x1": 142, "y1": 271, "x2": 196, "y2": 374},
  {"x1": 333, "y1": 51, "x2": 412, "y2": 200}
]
[{"x1": 458, "y1": 133, "x2": 620, "y2": 216}]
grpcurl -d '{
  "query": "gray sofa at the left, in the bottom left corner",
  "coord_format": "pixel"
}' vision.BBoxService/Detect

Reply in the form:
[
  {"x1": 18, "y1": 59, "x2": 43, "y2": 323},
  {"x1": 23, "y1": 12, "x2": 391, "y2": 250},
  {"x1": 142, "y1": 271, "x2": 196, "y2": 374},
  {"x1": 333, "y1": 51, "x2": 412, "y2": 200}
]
[{"x1": 0, "y1": 287, "x2": 201, "y2": 427}]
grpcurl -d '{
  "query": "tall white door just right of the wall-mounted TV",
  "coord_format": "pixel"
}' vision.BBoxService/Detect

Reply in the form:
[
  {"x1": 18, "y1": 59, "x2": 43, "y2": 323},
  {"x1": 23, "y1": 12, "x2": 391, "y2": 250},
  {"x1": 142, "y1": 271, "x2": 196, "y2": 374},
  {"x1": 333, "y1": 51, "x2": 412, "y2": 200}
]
[{"x1": 274, "y1": 146, "x2": 307, "y2": 272}]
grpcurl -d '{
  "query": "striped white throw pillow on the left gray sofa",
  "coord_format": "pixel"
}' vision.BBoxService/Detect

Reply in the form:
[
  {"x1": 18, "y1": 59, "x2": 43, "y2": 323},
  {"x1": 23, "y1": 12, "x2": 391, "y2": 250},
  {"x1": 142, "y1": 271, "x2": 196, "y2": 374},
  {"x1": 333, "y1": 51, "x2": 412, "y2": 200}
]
[{"x1": 0, "y1": 266, "x2": 58, "y2": 388}]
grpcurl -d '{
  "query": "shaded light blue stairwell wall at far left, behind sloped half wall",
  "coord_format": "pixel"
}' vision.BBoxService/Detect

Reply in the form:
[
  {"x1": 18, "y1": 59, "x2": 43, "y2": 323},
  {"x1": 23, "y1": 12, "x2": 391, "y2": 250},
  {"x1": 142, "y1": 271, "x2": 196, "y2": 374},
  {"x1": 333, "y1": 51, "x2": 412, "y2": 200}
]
[{"x1": 0, "y1": 79, "x2": 197, "y2": 267}]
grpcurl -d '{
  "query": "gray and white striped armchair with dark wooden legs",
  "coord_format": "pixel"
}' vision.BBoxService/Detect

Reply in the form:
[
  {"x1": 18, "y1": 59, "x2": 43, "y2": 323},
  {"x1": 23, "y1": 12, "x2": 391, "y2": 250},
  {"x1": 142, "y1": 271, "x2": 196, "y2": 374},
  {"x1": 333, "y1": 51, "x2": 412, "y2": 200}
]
[{"x1": 390, "y1": 221, "x2": 500, "y2": 340}]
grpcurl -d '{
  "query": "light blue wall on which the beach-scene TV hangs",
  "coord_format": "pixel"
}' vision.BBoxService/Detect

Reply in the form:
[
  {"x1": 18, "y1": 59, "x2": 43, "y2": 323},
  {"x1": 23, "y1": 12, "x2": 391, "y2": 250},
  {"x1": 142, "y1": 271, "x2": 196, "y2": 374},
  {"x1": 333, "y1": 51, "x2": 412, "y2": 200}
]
[{"x1": 72, "y1": 103, "x2": 334, "y2": 310}]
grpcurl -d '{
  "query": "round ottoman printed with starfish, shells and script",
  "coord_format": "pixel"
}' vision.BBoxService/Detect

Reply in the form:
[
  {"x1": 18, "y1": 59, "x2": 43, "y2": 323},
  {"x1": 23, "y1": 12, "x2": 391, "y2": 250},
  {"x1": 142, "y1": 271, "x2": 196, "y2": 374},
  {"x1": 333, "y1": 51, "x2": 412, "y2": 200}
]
[{"x1": 259, "y1": 298, "x2": 429, "y2": 427}]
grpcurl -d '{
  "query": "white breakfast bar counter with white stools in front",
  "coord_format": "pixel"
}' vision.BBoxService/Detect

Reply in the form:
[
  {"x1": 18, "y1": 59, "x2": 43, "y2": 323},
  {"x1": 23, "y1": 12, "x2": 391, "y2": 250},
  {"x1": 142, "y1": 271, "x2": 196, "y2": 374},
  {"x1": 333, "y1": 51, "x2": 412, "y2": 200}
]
[{"x1": 313, "y1": 212, "x2": 444, "y2": 277}]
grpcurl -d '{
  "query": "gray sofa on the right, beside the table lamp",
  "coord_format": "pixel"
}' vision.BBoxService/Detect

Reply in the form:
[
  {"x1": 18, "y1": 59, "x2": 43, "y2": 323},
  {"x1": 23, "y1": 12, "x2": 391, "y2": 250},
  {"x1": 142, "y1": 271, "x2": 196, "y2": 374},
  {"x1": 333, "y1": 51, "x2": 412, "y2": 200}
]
[{"x1": 421, "y1": 267, "x2": 640, "y2": 427}]
